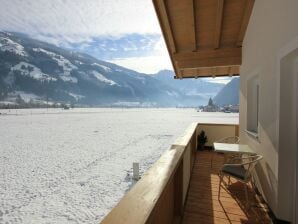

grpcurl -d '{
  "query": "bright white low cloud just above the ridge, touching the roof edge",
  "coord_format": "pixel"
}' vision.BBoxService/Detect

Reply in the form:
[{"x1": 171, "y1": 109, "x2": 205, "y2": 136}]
[{"x1": 110, "y1": 55, "x2": 173, "y2": 74}]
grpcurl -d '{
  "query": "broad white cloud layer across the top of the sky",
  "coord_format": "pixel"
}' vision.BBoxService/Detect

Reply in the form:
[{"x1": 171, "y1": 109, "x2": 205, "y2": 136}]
[{"x1": 0, "y1": 0, "x2": 160, "y2": 43}]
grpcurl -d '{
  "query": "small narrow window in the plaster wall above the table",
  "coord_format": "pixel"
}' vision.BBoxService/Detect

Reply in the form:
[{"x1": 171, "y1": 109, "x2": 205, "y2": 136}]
[{"x1": 246, "y1": 75, "x2": 260, "y2": 137}]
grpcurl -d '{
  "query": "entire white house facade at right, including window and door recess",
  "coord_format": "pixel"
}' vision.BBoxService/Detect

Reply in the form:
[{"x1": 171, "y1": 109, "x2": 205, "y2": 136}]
[{"x1": 239, "y1": 0, "x2": 298, "y2": 220}]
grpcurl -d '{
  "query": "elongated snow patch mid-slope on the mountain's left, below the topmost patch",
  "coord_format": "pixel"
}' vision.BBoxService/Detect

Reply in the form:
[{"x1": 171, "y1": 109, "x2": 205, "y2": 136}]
[{"x1": 11, "y1": 62, "x2": 57, "y2": 81}]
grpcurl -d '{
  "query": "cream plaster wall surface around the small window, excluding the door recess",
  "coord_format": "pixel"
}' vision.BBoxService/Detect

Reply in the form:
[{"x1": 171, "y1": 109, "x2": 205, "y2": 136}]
[{"x1": 239, "y1": 0, "x2": 298, "y2": 221}]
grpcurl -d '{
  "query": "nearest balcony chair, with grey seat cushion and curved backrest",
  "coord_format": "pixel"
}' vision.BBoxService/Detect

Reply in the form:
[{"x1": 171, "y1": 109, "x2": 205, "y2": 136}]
[{"x1": 218, "y1": 155, "x2": 263, "y2": 205}]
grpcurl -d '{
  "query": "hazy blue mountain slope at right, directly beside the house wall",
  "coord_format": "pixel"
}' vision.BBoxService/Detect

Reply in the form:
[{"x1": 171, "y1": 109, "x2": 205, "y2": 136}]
[{"x1": 213, "y1": 78, "x2": 240, "y2": 106}]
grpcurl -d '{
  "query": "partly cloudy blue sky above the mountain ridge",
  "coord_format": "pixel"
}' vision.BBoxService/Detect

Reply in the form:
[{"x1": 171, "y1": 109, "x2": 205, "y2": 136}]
[{"x1": 0, "y1": 0, "x2": 232, "y2": 82}]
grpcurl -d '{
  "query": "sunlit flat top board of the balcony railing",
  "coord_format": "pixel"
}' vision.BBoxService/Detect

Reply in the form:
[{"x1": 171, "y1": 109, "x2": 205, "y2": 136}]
[{"x1": 102, "y1": 146, "x2": 184, "y2": 223}]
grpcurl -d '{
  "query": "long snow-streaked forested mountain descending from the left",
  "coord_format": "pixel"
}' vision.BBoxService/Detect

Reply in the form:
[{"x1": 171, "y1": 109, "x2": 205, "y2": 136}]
[{"x1": 0, "y1": 32, "x2": 220, "y2": 106}]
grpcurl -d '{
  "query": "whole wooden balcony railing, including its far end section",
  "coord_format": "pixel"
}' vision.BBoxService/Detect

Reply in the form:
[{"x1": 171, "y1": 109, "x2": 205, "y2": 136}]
[{"x1": 102, "y1": 123, "x2": 238, "y2": 224}]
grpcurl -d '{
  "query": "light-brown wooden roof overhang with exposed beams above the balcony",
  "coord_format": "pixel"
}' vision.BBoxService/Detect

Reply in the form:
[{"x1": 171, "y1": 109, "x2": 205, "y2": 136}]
[{"x1": 153, "y1": 0, "x2": 254, "y2": 78}]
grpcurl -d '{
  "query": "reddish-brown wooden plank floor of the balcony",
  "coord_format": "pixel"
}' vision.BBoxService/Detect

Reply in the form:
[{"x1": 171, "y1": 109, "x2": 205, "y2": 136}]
[{"x1": 182, "y1": 151, "x2": 272, "y2": 224}]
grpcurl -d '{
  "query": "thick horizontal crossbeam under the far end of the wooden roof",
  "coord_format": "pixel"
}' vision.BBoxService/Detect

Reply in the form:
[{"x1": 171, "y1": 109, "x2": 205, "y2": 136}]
[{"x1": 177, "y1": 57, "x2": 241, "y2": 69}]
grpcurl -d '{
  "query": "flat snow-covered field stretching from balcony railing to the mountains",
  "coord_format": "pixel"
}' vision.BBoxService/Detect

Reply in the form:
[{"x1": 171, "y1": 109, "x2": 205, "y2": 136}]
[{"x1": 0, "y1": 109, "x2": 238, "y2": 223}]
